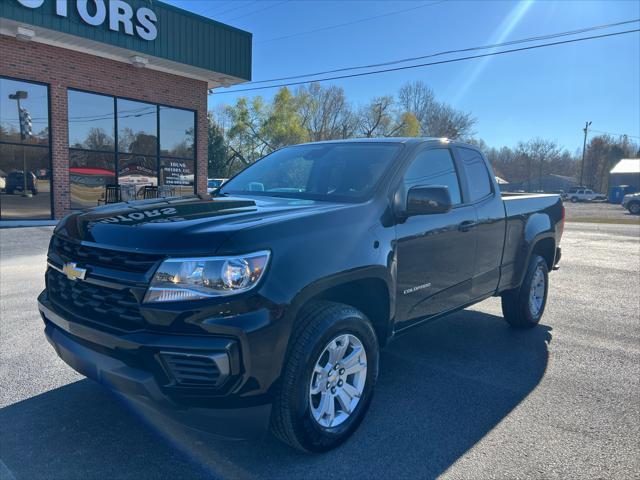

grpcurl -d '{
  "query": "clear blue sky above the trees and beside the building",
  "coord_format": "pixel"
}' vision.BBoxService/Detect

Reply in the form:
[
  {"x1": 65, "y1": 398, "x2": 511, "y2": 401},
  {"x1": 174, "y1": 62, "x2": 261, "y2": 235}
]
[{"x1": 170, "y1": 0, "x2": 640, "y2": 151}]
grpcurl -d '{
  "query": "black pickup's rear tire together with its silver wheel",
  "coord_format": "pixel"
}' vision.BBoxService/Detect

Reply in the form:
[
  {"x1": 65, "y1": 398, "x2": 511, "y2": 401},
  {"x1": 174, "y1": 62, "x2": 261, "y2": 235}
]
[{"x1": 502, "y1": 255, "x2": 549, "y2": 328}]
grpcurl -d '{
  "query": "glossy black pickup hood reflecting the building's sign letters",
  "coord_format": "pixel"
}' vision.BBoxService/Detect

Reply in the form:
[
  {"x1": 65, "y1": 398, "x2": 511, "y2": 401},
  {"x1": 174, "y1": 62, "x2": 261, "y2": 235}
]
[{"x1": 55, "y1": 196, "x2": 350, "y2": 255}]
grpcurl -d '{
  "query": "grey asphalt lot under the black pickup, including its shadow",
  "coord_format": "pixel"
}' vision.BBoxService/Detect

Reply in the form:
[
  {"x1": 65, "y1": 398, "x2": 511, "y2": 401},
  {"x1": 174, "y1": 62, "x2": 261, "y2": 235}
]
[{"x1": 0, "y1": 223, "x2": 640, "y2": 479}]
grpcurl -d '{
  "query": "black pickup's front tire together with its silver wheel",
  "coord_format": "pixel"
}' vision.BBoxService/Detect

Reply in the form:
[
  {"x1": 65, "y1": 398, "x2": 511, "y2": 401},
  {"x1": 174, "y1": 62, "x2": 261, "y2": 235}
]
[{"x1": 271, "y1": 301, "x2": 379, "y2": 452}]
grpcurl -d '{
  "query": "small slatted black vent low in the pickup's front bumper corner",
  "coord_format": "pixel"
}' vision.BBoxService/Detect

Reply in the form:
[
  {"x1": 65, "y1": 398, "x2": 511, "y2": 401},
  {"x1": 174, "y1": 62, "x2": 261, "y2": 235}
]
[{"x1": 160, "y1": 352, "x2": 226, "y2": 387}]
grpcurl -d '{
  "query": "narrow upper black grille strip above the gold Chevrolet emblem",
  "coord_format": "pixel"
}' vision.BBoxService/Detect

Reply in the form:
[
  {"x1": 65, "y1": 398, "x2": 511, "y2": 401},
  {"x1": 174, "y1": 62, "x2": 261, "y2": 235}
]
[{"x1": 51, "y1": 236, "x2": 161, "y2": 273}]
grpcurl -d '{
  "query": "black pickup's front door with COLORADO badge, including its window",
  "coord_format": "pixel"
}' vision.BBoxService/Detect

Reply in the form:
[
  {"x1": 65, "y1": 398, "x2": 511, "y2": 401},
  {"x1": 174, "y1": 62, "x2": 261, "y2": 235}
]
[{"x1": 396, "y1": 147, "x2": 476, "y2": 328}]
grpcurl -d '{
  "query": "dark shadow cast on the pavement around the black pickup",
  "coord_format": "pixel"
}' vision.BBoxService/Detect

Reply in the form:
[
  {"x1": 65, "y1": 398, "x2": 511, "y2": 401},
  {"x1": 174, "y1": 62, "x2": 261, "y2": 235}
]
[{"x1": 0, "y1": 311, "x2": 551, "y2": 479}]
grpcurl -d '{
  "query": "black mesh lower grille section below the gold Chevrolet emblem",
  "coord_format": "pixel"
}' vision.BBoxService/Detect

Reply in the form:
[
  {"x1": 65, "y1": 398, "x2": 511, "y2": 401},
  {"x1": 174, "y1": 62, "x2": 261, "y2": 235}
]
[{"x1": 47, "y1": 268, "x2": 144, "y2": 330}]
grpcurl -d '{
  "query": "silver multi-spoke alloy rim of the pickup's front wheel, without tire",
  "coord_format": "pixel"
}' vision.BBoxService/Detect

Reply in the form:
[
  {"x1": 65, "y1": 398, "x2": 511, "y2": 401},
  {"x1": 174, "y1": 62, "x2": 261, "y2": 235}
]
[{"x1": 309, "y1": 334, "x2": 367, "y2": 428}]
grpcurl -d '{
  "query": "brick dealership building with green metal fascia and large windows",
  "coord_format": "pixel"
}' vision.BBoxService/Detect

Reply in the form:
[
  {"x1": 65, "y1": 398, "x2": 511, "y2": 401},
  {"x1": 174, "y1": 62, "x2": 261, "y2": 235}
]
[{"x1": 0, "y1": 0, "x2": 251, "y2": 221}]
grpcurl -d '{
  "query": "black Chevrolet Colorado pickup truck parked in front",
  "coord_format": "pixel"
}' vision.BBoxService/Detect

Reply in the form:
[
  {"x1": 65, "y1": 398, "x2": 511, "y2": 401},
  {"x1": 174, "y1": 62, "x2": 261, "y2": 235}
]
[{"x1": 39, "y1": 139, "x2": 564, "y2": 451}]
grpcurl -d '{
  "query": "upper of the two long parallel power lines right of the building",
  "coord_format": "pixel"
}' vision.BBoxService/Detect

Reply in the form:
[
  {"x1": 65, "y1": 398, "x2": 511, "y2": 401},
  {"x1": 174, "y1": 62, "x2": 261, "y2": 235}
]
[{"x1": 245, "y1": 19, "x2": 640, "y2": 86}]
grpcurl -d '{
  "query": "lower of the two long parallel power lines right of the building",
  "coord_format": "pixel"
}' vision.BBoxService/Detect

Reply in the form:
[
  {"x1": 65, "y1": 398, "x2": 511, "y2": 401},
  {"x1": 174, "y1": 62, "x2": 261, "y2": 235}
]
[{"x1": 210, "y1": 28, "x2": 640, "y2": 95}]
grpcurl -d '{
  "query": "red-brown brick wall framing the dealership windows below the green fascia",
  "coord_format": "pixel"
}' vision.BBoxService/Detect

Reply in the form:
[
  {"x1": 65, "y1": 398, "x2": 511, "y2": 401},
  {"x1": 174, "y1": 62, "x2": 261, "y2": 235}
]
[{"x1": 0, "y1": 35, "x2": 207, "y2": 218}]
